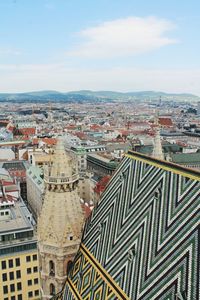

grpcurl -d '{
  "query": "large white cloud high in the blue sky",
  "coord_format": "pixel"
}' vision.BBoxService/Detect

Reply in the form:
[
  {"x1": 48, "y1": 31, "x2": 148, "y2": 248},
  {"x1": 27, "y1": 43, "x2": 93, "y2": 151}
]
[{"x1": 68, "y1": 17, "x2": 177, "y2": 58}]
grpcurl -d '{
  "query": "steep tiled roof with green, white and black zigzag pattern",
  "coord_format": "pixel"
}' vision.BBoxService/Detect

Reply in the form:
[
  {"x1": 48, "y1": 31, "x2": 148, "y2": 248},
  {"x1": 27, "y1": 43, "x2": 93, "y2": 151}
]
[{"x1": 54, "y1": 151, "x2": 200, "y2": 300}]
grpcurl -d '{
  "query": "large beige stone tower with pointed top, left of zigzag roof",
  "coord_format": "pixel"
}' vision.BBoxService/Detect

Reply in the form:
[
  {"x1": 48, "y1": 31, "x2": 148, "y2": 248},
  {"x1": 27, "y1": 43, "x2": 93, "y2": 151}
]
[{"x1": 38, "y1": 140, "x2": 84, "y2": 299}]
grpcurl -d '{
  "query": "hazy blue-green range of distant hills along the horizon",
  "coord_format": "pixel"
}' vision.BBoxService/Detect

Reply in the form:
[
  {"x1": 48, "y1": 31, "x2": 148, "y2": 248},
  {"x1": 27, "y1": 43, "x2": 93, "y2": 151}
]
[{"x1": 0, "y1": 90, "x2": 199, "y2": 103}]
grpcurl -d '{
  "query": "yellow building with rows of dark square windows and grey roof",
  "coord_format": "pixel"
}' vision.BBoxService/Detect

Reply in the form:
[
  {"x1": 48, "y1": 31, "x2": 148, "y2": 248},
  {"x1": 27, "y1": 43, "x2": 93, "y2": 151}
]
[{"x1": 0, "y1": 179, "x2": 40, "y2": 300}]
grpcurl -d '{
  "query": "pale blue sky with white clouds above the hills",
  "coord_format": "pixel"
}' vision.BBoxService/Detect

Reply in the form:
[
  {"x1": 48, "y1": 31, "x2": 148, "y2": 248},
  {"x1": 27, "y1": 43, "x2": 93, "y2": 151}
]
[{"x1": 0, "y1": 0, "x2": 200, "y2": 96}]
